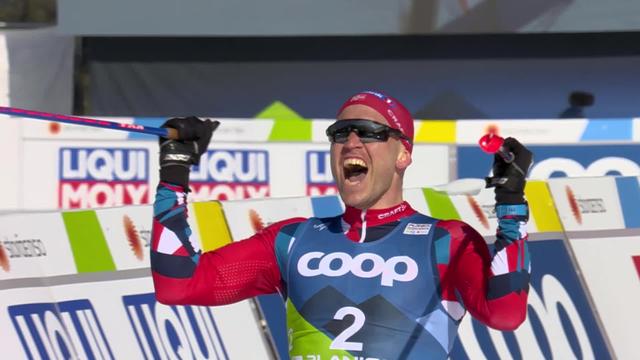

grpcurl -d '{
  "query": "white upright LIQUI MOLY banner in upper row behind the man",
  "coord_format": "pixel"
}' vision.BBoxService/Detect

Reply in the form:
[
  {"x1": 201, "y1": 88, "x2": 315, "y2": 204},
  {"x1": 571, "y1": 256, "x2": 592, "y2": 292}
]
[{"x1": 20, "y1": 139, "x2": 453, "y2": 209}]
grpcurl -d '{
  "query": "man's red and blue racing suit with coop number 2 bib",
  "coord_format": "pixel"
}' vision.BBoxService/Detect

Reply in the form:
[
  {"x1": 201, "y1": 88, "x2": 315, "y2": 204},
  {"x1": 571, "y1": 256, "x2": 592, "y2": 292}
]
[{"x1": 151, "y1": 183, "x2": 530, "y2": 359}]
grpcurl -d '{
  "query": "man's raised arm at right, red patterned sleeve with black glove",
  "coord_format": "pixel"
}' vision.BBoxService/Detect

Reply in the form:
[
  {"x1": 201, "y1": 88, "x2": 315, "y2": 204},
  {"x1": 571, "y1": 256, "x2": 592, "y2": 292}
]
[{"x1": 435, "y1": 138, "x2": 532, "y2": 330}]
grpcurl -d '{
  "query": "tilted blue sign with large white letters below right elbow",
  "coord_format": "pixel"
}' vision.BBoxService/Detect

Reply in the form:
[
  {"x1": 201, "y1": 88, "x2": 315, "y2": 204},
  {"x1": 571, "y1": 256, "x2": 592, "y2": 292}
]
[{"x1": 451, "y1": 239, "x2": 610, "y2": 359}]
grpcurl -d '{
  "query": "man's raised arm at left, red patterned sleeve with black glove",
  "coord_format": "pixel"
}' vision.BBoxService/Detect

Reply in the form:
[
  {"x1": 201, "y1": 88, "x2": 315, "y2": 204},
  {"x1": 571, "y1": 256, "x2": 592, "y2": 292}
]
[{"x1": 151, "y1": 117, "x2": 302, "y2": 305}]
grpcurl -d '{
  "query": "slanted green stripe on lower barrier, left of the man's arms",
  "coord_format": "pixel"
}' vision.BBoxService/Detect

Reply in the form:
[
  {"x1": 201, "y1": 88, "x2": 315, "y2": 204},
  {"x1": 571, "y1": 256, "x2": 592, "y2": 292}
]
[{"x1": 62, "y1": 210, "x2": 116, "y2": 273}]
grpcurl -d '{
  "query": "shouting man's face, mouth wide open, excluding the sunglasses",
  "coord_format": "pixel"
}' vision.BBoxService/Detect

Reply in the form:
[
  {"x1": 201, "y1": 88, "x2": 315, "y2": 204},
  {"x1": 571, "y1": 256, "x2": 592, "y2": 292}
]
[{"x1": 331, "y1": 105, "x2": 411, "y2": 209}]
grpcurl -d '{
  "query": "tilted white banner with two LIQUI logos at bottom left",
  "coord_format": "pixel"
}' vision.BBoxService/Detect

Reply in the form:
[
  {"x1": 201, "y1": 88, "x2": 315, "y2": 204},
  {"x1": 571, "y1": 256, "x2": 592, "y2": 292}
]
[{"x1": 0, "y1": 278, "x2": 272, "y2": 360}]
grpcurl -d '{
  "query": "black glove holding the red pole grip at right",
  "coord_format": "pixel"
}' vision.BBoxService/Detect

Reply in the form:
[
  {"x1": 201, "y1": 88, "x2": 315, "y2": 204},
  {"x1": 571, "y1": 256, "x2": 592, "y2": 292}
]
[{"x1": 485, "y1": 137, "x2": 533, "y2": 205}]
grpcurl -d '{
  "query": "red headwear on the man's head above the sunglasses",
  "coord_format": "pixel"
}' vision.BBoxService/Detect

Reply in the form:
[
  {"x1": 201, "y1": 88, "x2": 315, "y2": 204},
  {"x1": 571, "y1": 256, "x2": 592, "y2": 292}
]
[{"x1": 338, "y1": 91, "x2": 413, "y2": 152}]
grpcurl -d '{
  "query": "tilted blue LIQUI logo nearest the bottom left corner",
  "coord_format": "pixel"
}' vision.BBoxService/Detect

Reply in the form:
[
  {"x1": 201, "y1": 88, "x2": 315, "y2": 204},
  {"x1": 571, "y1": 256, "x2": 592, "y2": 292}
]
[{"x1": 8, "y1": 299, "x2": 114, "y2": 359}]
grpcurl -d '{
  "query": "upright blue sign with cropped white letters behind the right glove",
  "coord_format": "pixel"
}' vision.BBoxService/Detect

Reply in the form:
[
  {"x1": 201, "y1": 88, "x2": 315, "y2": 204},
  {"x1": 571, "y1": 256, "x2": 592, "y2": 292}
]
[{"x1": 458, "y1": 143, "x2": 640, "y2": 179}]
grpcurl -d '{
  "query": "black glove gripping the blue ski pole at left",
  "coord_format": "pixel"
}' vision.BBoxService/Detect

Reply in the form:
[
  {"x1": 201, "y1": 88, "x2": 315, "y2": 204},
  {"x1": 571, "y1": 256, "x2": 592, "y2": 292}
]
[{"x1": 159, "y1": 116, "x2": 220, "y2": 189}]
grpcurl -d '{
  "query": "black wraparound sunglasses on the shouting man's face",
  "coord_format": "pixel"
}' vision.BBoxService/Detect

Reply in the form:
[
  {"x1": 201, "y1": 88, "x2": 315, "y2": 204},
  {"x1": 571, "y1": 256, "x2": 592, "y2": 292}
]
[{"x1": 326, "y1": 119, "x2": 412, "y2": 144}]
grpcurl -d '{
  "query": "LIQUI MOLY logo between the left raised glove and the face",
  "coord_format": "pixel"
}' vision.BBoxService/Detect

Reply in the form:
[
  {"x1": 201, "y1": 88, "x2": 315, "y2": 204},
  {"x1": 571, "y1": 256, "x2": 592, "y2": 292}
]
[{"x1": 189, "y1": 150, "x2": 270, "y2": 201}]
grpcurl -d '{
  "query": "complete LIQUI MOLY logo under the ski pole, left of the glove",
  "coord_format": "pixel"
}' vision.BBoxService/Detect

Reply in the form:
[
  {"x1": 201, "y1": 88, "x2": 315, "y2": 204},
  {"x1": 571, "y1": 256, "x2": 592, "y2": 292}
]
[{"x1": 58, "y1": 148, "x2": 149, "y2": 208}]
